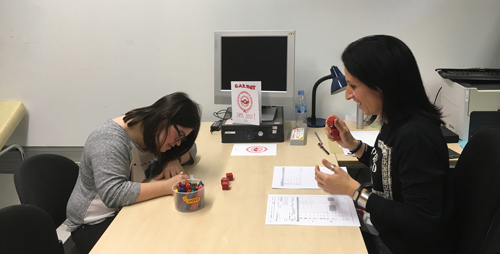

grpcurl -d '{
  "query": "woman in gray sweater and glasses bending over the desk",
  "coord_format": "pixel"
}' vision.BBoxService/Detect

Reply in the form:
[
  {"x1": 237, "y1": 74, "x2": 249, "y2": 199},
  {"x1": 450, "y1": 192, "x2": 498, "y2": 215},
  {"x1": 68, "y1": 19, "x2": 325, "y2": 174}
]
[{"x1": 66, "y1": 93, "x2": 200, "y2": 253}]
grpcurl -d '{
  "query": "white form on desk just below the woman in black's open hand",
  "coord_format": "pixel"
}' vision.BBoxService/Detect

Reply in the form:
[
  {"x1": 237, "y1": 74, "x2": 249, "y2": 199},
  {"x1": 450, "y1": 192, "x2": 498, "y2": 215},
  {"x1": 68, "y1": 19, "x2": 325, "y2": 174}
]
[{"x1": 272, "y1": 166, "x2": 347, "y2": 189}]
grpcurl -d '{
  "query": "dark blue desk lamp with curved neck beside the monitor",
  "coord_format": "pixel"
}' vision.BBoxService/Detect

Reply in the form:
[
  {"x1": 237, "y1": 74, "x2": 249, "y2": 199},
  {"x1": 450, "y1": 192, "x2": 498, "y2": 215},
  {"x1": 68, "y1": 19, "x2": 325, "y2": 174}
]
[{"x1": 307, "y1": 65, "x2": 347, "y2": 127}]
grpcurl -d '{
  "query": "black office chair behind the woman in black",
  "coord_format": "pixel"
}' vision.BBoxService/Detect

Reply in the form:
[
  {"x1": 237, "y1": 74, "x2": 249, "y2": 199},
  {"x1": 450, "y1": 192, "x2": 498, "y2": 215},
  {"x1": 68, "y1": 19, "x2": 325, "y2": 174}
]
[{"x1": 451, "y1": 129, "x2": 500, "y2": 254}]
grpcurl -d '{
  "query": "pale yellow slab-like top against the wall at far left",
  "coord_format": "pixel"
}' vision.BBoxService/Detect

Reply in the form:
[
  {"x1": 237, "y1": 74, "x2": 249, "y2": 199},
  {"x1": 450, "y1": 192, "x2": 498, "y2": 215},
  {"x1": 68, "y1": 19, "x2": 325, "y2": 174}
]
[{"x1": 0, "y1": 101, "x2": 26, "y2": 149}]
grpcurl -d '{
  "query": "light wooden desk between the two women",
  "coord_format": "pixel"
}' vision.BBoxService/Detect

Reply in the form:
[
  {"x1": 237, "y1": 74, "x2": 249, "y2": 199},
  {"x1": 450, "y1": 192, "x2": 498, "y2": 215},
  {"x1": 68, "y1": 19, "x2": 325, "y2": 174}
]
[{"x1": 91, "y1": 122, "x2": 367, "y2": 254}]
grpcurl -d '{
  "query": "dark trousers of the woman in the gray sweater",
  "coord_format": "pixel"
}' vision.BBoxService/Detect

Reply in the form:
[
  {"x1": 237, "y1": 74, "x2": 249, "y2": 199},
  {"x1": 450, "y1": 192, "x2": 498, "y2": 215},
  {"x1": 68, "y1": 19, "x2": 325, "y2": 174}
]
[{"x1": 71, "y1": 216, "x2": 115, "y2": 254}]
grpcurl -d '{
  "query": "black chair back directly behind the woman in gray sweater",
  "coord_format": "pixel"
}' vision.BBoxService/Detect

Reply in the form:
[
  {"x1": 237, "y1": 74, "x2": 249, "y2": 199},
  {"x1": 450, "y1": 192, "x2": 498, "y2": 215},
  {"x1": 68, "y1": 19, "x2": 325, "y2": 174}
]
[{"x1": 14, "y1": 154, "x2": 79, "y2": 228}]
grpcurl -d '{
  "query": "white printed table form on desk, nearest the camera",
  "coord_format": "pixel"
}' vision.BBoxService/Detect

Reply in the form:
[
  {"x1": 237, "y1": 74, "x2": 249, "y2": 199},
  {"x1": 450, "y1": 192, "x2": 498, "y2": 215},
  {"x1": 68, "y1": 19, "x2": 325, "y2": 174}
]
[{"x1": 266, "y1": 194, "x2": 360, "y2": 227}]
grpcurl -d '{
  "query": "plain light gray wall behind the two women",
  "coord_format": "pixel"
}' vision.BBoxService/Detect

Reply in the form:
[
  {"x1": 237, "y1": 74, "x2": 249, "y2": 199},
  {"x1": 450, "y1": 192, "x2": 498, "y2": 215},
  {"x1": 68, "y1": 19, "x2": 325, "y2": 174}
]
[{"x1": 0, "y1": 0, "x2": 500, "y2": 146}]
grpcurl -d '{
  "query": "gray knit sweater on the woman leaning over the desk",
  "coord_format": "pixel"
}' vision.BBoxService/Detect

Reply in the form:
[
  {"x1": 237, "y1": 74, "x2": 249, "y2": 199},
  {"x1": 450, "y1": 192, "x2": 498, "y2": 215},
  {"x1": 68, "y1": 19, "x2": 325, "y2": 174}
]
[{"x1": 66, "y1": 119, "x2": 196, "y2": 231}]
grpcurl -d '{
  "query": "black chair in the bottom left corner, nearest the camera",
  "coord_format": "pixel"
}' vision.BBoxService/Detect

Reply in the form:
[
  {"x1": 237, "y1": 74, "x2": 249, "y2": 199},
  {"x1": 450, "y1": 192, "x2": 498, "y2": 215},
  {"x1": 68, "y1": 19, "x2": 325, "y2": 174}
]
[{"x1": 0, "y1": 205, "x2": 64, "y2": 254}]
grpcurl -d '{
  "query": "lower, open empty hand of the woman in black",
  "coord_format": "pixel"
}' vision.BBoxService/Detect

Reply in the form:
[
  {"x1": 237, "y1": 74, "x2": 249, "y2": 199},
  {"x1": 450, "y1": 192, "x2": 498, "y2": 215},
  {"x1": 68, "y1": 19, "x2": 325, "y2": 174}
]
[{"x1": 315, "y1": 159, "x2": 360, "y2": 197}]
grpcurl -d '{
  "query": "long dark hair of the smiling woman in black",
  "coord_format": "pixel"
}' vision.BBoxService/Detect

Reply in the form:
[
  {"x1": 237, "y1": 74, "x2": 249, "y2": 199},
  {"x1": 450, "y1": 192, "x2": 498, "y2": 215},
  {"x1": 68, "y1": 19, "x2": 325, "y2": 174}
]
[{"x1": 342, "y1": 35, "x2": 444, "y2": 126}]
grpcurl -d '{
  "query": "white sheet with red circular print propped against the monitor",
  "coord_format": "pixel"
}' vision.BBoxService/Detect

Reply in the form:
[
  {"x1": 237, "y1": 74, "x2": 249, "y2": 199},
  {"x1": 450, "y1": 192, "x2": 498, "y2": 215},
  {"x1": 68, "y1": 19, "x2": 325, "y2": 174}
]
[{"x1": 231, "y1": 81, "x2": 262, "y2": 125}]
